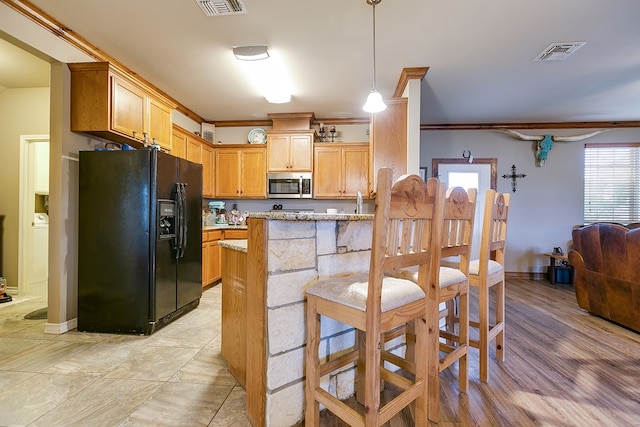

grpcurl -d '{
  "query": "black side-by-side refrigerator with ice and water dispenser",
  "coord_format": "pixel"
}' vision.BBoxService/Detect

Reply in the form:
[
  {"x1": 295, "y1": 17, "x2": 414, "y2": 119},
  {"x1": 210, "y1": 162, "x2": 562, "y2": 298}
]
[{"x1": 77, "y1": 149, "x2": 202, "y2": 335}]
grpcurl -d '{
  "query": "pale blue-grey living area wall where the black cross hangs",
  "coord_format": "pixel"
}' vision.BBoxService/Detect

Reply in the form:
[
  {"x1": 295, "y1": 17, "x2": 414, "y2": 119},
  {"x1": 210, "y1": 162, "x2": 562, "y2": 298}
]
[{"x1": 420, "y1": 128, "x2": 640, "y2": 273}]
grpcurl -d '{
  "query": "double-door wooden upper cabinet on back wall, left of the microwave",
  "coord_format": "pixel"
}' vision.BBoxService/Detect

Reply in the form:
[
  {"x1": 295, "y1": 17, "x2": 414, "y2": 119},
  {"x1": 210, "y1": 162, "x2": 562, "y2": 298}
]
[{"x1": 214, "y1": 144, "x2": 267, "y2": 199}]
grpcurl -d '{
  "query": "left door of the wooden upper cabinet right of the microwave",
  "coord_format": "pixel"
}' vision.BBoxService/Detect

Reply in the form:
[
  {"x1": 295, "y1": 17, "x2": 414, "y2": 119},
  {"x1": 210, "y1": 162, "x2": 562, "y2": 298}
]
[{"x1": 313, "y1": 147, "x2": 342, "y2": 198}]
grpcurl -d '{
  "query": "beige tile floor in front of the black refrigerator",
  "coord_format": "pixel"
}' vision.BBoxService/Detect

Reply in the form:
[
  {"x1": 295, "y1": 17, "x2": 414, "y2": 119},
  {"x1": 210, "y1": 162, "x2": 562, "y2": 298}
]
[{"x1": 0, "y1": 286, "x2": 250, "y2": 427}]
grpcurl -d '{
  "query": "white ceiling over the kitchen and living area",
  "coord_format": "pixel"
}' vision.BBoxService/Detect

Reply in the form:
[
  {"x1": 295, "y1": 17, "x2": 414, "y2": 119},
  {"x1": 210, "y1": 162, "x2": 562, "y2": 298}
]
[{"x1": 0, "y1": 0, "x2": 640, "y2": 124}]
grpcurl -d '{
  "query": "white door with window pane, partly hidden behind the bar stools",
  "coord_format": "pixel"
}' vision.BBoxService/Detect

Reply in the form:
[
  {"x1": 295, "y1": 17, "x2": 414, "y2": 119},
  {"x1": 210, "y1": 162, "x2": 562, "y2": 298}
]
[{"x1": 432, "y1": 158, "x2": 498, "y2": 259}]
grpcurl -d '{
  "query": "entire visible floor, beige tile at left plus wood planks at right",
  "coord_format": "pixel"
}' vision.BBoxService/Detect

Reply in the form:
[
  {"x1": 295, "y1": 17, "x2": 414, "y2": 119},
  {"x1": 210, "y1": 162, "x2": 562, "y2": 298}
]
[{"x1": 0, "y1": 279, "x2": 640, "y2": 427}]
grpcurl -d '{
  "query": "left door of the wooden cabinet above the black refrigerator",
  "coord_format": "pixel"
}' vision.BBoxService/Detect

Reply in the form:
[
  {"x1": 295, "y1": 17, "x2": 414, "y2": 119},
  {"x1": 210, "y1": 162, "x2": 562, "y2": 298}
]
[{"x1": 111, "y1": 76, "x2": 147, "y2": 140}]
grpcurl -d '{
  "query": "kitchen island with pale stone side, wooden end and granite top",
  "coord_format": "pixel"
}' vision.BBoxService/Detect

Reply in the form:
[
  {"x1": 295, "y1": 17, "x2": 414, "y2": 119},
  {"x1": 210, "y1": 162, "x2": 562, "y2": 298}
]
[{"x1": 220, "y1": 212, "x2": 373, "y2": 426}]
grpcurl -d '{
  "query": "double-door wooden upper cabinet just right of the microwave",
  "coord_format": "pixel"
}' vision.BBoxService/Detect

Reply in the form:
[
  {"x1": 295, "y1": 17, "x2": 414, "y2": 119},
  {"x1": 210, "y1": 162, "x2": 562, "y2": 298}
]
[{"x1": 313, "y1": 143, "x2": 369, "y2": 199}]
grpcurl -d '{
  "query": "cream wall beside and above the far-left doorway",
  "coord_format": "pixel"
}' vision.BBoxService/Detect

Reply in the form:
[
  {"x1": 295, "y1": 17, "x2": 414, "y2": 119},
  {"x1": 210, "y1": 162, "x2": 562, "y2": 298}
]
[{"x1": 0, "y1": 87, "x2": 49, "y2": 287}]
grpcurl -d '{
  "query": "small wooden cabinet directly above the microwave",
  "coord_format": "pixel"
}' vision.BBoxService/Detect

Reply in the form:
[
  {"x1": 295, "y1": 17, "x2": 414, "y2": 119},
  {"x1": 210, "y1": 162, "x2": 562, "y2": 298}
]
[{"x1": 267, "y1": 130, "x2": 315, "y2": 172}]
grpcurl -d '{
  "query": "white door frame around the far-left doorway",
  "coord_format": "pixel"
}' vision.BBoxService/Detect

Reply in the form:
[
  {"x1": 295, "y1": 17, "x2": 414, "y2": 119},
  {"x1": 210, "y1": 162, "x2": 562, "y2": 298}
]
[{"x1": 16, "y1": 135, "x2": 49, "y2": 294}]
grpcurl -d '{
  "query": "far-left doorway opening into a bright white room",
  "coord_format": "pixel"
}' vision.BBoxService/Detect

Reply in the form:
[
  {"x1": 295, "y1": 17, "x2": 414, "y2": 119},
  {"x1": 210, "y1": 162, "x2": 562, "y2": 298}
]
[{"x1": 18, "y1": 135, "x2": 49, "y2": 302}]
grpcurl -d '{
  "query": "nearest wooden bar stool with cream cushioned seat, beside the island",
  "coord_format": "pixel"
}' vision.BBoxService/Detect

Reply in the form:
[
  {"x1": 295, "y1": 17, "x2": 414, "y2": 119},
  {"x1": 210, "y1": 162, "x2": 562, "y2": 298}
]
[{"x1": 305, "y1": 168, "x2": 444, "y2": 426}]
